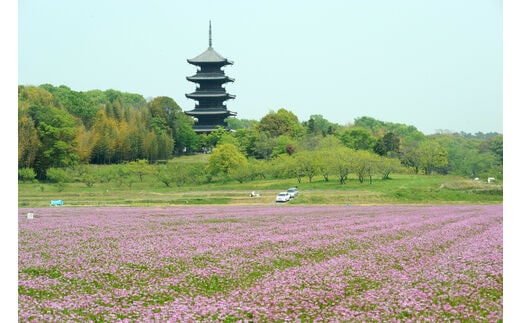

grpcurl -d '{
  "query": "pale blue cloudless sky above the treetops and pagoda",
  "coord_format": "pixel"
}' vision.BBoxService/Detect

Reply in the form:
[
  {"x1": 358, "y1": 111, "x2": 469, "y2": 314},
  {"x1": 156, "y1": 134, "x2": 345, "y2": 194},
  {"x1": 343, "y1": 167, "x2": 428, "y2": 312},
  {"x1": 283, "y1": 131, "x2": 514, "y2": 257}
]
[{"x1": 18, "y1": 0, "x2": 503, "y2": 134}]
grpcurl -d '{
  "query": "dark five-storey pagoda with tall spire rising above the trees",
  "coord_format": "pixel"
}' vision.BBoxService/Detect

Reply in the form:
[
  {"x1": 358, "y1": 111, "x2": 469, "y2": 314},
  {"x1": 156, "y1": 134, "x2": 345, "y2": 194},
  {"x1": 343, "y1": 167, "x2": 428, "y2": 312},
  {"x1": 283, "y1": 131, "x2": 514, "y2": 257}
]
[{"x1": 184, "y1": 21, "x2": 236, "y2": 133}]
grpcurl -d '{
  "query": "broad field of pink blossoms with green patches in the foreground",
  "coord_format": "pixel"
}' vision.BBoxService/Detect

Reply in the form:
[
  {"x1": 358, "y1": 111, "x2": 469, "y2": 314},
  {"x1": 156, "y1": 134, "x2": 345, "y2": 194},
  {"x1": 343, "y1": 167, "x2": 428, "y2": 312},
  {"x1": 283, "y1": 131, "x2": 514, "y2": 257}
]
[{"x1": 18, "y1": 205, "x2": 503, "y2": 322}]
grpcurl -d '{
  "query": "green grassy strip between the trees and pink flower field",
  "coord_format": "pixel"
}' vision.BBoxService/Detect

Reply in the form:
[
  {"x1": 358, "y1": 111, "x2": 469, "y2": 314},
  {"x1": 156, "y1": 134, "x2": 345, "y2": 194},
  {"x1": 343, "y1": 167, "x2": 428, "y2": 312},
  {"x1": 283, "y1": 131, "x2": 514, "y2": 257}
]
[{"x1": 18, "y1": 162, "x2": 502, "y2": 207}]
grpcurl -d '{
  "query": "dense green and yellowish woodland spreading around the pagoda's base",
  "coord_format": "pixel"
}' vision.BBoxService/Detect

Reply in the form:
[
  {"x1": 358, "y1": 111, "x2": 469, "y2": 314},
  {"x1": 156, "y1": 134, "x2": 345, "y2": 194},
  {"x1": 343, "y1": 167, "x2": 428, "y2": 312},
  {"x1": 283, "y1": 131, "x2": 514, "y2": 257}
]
[{"x1": 18, "y1": 84, "x2": 503, "y2": 182}]
